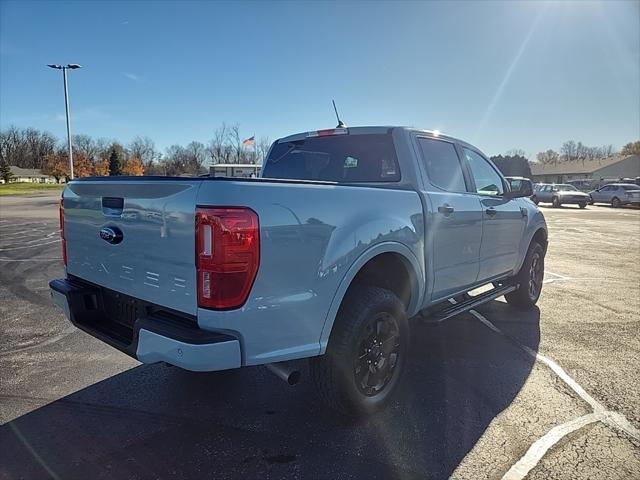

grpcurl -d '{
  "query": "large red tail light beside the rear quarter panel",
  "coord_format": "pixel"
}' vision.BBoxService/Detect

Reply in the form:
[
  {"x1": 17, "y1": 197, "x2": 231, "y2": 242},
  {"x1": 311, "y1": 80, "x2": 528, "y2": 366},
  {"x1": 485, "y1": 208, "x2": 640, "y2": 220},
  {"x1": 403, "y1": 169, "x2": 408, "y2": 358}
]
[{"x1": 196, "y1": 207, "x2": 260, "y2": 309}]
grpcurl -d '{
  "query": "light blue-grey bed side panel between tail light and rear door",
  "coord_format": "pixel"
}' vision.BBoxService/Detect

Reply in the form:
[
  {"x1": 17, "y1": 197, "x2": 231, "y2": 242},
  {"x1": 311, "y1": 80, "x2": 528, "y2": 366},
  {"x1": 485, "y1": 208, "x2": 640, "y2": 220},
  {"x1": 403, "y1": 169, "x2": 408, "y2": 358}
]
[{"x1": 197, "y1": 181, "x2": 424, "y2": 365}]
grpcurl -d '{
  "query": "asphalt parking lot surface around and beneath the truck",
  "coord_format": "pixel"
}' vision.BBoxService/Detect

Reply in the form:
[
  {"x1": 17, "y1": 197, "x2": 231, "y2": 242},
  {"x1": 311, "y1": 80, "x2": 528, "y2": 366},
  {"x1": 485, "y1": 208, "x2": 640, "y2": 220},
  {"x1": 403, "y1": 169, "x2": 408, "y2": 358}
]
[{"x1": 0, "y1": 196, "x2": 640, "y2": 479}]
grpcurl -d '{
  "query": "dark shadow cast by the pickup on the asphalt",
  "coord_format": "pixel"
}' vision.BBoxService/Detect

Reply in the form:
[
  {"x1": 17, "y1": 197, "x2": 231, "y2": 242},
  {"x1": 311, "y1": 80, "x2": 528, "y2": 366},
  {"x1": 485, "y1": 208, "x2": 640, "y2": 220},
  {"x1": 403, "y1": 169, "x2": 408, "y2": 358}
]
[{"x1": 0, "y1": 302, "x2": 540, "y2": 479}]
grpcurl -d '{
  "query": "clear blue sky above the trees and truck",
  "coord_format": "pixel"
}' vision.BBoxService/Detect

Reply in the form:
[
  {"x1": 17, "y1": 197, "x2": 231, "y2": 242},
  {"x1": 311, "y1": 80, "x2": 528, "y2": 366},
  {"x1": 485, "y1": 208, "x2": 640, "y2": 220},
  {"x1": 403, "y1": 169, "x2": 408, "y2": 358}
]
[{"x1": 0, "y1": 0, "x2": 640, "y2": 158}]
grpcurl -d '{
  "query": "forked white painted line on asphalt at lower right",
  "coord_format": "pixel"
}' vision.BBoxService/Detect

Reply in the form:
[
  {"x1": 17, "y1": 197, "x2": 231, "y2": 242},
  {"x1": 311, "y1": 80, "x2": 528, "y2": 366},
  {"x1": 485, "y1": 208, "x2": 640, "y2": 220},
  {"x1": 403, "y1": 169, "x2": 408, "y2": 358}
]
[{"x1": 469, "y1": 310, "x2": 640, "y2": 480}]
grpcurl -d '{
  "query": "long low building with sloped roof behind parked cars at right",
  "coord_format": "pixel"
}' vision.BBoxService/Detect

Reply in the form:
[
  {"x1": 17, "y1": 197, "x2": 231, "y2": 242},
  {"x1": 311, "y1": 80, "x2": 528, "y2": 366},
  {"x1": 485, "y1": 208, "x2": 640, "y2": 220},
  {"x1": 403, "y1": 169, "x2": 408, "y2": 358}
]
[{"x1": 531, "y1": 155, "x2": 640, "y2": 183}]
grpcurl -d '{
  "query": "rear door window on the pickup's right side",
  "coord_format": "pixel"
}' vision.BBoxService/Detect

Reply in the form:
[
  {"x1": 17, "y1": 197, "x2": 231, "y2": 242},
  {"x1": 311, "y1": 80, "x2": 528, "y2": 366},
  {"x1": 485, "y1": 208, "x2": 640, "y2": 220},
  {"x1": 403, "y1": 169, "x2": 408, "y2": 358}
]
[{"x1": 418, "y1": 137, "x2": 467, "y2": 192}]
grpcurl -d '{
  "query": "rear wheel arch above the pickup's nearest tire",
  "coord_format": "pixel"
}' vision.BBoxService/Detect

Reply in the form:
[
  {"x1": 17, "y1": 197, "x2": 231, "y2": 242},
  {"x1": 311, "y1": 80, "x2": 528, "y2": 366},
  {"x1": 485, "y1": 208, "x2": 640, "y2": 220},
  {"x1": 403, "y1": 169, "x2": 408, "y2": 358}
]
[{"x1": 320, "y1": 242, "x2": 425, "y2": 354}]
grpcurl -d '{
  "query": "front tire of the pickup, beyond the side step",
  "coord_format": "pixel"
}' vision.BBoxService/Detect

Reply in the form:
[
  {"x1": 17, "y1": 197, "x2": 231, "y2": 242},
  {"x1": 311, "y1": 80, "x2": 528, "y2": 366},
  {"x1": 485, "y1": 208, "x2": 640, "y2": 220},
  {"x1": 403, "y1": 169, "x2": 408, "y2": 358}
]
[{"x1": 504, "y1": 240, "x2": 545, "y2": 308}]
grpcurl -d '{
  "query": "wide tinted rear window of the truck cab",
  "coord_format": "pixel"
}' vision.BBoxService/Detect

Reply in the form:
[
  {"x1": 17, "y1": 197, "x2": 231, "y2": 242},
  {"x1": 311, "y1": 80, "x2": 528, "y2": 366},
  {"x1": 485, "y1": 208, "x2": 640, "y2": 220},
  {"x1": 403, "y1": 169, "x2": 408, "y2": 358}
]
[{"x1": 262, "y1": 133, "x2": 400, "y2": 183}]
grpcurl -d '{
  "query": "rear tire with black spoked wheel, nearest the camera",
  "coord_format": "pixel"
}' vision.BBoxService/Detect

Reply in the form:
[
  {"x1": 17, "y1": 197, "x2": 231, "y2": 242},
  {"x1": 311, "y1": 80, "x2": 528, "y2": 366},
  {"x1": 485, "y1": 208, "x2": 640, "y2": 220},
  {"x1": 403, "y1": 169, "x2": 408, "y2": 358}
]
[{"x1": 309, "y1": 286, "x2": 409, "y2": 416}]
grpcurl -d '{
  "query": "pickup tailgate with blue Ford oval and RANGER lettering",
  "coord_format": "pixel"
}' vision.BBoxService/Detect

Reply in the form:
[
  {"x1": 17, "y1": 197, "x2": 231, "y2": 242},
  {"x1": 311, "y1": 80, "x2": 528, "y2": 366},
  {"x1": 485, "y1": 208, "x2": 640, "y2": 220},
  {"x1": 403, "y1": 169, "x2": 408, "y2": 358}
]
[{"x1": 63, "y1": 178, "x2": 201, "y2": 315}]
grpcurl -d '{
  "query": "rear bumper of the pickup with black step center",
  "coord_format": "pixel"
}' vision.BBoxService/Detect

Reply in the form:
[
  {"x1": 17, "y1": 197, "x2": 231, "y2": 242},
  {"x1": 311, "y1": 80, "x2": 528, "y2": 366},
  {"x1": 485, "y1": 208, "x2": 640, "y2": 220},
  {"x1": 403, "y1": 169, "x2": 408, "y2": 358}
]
[{"x1": 49, "y1": 279, "x2": 242, "y2": 371}]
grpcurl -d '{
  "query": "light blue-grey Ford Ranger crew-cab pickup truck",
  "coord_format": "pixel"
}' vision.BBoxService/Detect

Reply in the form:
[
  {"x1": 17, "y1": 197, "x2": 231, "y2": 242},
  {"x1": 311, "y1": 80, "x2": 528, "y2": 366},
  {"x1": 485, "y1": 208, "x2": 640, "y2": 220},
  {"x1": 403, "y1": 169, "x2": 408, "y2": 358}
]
[{"x1": 50, "y1": 127, "x2": 547, "y2": 415}]
